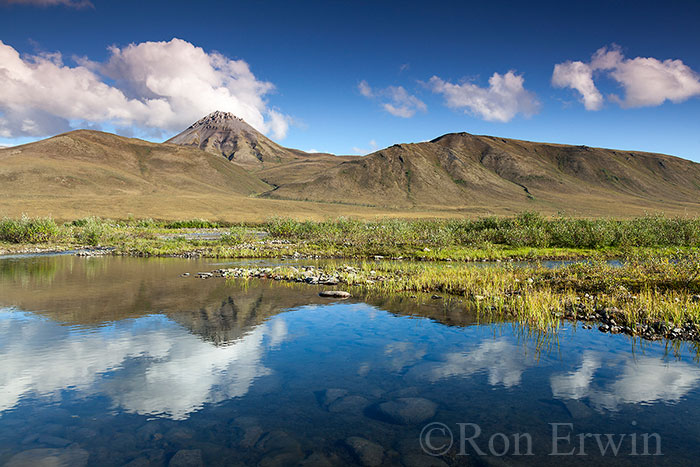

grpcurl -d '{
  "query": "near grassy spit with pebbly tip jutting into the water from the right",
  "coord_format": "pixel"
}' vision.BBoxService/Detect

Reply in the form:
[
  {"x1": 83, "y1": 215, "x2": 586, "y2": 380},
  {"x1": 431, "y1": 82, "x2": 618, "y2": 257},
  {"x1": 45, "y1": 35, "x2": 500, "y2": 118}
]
[{"x1": 213, "y1": 254, "x2": 700, "y2": 341}]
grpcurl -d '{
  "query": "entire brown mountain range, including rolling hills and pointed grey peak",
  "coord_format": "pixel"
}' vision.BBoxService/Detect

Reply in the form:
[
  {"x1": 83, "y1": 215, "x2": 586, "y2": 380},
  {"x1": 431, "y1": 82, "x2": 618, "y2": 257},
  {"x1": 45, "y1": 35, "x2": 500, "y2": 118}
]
[{"x1": 0, "y1": 112, "x2": 700, "y2": 221}]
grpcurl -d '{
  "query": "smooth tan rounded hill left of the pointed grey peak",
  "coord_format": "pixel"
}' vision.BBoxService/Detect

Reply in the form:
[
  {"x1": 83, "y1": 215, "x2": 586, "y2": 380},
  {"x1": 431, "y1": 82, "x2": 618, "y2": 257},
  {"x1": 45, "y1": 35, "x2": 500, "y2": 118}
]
[{"x1": 0, "y1": 130, "x2": 269, "y2": 197}]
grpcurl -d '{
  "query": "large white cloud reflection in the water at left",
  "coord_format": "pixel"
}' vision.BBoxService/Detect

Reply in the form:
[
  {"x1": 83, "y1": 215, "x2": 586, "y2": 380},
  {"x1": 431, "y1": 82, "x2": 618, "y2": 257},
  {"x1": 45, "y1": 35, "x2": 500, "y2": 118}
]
[{"x1": 0, "y1": 313, "x2": 287, "y2": 419}]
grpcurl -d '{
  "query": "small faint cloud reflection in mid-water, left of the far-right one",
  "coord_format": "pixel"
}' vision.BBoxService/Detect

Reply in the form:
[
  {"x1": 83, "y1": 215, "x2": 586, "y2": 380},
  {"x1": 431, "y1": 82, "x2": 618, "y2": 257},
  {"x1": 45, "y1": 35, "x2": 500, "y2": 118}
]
[{"x1": 408, "y1": 339, "x2": 528, "y2": 388}]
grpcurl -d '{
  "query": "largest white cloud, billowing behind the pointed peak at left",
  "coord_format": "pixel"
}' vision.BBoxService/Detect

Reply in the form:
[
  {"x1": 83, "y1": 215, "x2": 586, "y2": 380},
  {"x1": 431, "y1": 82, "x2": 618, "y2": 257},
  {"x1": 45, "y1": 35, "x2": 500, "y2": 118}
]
[{"x1": 0, "y1": 38, "x2": 290, "y2": 138}]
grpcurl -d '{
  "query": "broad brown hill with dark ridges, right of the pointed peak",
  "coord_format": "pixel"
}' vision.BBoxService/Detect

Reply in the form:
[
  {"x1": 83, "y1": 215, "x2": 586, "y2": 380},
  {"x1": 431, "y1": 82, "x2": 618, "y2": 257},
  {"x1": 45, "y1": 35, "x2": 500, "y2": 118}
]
[{"x1": 265, "y1": 133, "x2": 700, "y2": 215}]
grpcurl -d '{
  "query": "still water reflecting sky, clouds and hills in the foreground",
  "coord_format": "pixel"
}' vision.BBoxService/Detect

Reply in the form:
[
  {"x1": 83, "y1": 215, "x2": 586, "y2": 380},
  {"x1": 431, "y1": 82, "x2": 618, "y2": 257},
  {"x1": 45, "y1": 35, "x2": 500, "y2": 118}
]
[{"x1": 0, "y1": 256, "x2": 700, "y2": 466}]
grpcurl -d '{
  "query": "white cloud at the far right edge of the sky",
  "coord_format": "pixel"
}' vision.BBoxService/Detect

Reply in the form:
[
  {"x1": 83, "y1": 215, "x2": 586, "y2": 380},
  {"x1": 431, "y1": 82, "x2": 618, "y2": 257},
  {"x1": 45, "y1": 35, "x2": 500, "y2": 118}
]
[{"x1": 552, "y1": 45, "x2": 700, "y2": 110}]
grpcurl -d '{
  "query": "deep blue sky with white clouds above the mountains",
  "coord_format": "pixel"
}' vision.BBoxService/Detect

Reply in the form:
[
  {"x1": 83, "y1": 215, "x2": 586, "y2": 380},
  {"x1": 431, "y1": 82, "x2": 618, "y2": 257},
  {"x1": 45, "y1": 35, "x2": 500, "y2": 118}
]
[{"x1": 0, "y1": 0, "x2": 700, "y2": 162}]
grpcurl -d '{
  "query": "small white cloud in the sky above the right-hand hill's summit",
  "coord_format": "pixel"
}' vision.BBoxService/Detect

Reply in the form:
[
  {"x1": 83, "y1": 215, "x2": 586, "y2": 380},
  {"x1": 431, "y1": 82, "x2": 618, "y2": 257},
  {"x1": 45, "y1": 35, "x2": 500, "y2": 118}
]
[{"x1": 428, "y1": 71, "x2": 540, "y2": 122}]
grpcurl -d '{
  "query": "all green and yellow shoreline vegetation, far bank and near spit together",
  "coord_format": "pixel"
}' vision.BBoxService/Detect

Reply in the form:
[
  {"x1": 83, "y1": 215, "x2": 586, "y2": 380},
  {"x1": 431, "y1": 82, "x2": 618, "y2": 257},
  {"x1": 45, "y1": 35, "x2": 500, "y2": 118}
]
[{"x1": 0, "y1": 213, "x2": 700, "y2": 341}]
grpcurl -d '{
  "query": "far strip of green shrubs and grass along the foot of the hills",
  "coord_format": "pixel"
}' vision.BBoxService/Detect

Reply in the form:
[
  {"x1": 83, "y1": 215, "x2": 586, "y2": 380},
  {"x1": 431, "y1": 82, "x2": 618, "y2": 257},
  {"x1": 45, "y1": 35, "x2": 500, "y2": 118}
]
[{"x1": 0, "y1": 213, "x2": 700, "y2": 261}]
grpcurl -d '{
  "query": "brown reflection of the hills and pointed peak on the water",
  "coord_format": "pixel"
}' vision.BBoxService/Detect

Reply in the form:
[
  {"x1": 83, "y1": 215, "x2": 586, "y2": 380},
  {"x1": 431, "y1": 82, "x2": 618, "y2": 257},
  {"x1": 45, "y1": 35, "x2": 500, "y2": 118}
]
[{"x1": 0, "y1": 256, "x2": 482, "y2": 344}]
